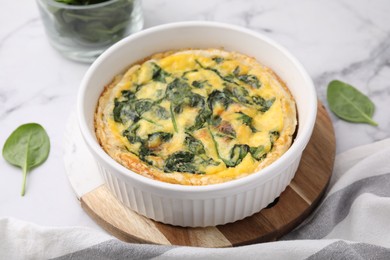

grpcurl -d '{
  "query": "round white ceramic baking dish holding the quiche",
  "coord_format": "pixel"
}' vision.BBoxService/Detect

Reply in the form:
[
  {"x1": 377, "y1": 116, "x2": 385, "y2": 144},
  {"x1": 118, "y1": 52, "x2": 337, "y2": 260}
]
[{"x1": 78, "y1": 22, "x2": 317, "y2": 227}]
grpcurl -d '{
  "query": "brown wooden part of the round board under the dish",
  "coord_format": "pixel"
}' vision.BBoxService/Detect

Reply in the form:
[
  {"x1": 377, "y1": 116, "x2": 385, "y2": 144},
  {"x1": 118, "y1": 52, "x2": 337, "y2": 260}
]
[{"x1": 80, "y1": 102, "x2": 336, "y2": 247}]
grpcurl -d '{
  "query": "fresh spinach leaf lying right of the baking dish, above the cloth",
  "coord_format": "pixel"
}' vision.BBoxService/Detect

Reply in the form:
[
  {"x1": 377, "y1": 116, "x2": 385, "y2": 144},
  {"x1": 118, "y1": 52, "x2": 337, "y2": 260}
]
[{"x1": 327, "y1": 80, "x2": 378, "y2": 126}]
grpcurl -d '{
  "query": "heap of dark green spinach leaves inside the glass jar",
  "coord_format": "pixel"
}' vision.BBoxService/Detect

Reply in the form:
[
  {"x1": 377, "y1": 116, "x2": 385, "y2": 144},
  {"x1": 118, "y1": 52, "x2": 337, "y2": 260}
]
[{"x1": 51, "y1": 0, "x2": 136, "y2": 45}]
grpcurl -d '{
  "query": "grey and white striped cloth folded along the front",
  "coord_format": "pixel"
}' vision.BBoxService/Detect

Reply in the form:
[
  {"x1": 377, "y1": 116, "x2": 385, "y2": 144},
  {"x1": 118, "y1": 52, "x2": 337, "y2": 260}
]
[{"x1": 0, "y1": 139, "x2": 390, "y2": 260}]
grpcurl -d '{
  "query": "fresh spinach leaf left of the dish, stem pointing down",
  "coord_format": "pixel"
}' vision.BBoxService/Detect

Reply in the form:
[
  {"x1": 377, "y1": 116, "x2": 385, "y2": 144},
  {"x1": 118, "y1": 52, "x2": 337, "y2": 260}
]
[{"x1": 3, "y1": 123, "x2": 50, "y2": 196}]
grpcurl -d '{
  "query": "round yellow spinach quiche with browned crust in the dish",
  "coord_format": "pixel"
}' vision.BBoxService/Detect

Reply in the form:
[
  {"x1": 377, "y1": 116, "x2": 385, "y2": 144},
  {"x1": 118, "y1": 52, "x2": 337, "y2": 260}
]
[{"x1": 95, "y1": 49, "x2": 297, "y2": 185}]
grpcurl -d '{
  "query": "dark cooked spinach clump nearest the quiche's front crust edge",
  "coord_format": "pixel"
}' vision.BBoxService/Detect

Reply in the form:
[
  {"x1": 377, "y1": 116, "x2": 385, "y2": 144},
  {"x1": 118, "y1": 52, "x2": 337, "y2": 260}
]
[{"x1": 164, "y1": 151, "x2": 201, "y2": 173}]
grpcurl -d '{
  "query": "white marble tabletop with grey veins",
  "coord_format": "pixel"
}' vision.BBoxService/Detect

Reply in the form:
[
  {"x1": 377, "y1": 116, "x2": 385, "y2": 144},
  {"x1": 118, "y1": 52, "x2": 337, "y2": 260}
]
[{"x1": 0, "y1": 0, "x2": 390, "y2": 231}]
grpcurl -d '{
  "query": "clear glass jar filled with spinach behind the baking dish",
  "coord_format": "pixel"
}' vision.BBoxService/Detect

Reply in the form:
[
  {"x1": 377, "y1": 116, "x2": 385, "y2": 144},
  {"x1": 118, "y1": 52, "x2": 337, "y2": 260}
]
[{"x1": 37, "y1": 0, "x2": 143, "y2": 63}]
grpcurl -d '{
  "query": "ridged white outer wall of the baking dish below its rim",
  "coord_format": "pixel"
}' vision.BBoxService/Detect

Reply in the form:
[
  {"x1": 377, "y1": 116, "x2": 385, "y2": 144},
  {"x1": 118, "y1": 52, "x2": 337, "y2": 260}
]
[{"x1": 98, "y1": 153, "x2": 300, "y2": 227}]
